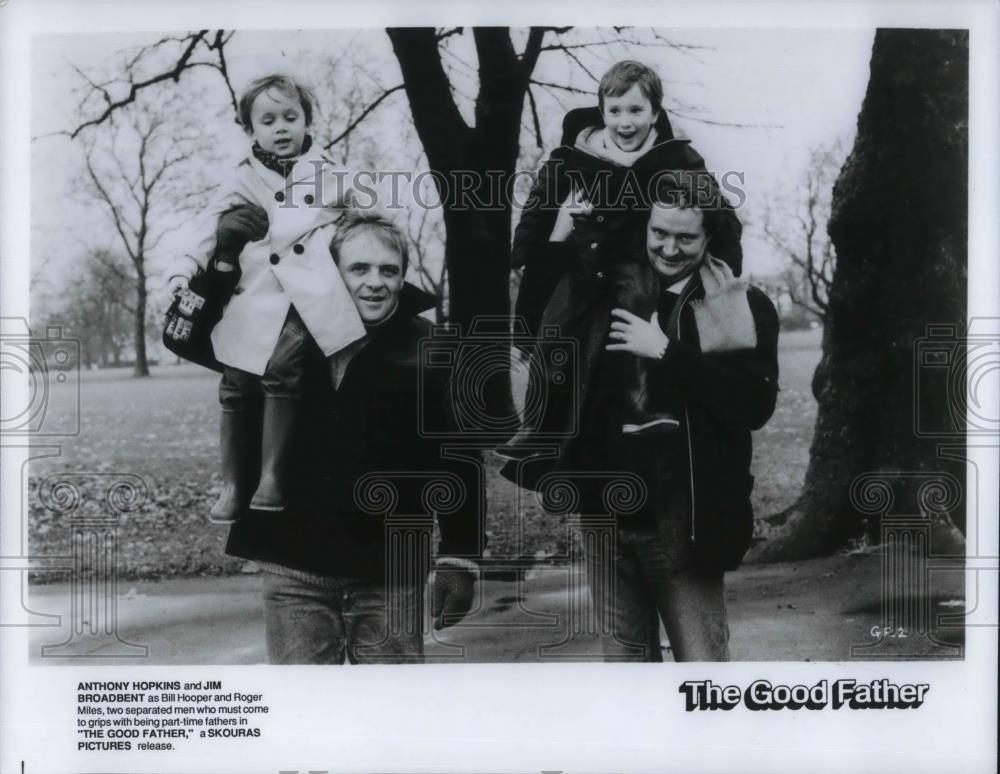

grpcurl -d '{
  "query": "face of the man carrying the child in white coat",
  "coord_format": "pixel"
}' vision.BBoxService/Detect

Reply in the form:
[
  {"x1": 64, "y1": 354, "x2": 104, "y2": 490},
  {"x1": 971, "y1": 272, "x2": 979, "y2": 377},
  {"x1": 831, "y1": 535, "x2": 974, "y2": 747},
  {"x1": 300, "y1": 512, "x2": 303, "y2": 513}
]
[{"x1": 338, "y1": 233, "x2": 403, "y2": 323}]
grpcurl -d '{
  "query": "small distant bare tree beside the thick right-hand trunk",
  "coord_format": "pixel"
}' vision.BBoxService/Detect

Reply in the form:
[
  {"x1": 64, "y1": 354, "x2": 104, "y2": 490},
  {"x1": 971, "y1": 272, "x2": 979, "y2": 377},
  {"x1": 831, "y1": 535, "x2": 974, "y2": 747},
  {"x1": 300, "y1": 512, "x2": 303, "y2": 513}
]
[{"x1": 763, "y1": 140, "x2": 846, "y2": 321}]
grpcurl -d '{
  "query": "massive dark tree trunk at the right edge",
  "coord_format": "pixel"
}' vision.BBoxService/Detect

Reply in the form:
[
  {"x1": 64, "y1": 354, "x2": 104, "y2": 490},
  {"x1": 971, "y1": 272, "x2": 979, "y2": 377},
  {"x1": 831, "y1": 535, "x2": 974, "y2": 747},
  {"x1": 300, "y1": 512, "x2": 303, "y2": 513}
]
[{"x1": 751, "y1": 29, "x2": 968, "y2": 560}]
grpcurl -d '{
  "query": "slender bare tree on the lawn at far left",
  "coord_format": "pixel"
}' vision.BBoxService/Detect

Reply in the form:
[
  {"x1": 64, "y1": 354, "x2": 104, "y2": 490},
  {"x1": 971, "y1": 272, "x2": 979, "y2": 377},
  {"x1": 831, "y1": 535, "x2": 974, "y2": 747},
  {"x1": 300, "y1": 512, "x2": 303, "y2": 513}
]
[{"x1": 81, "y1": 96, "x2": 214, "y2": 376}]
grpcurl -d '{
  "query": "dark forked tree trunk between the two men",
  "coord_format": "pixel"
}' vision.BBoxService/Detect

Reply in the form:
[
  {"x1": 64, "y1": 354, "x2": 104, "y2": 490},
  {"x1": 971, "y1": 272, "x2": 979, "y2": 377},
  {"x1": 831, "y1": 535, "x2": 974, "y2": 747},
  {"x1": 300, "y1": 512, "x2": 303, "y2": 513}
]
[{"x1": 386, "y1": 28, "x2": 528, "y2": 433}]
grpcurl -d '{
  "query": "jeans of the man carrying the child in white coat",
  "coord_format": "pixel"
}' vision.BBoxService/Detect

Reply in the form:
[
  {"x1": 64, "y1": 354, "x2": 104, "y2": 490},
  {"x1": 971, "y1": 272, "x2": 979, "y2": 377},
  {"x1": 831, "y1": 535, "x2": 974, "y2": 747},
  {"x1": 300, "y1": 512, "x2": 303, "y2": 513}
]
[{"x1": 263, "y1": 571, "x2": 424, "y2": 664}]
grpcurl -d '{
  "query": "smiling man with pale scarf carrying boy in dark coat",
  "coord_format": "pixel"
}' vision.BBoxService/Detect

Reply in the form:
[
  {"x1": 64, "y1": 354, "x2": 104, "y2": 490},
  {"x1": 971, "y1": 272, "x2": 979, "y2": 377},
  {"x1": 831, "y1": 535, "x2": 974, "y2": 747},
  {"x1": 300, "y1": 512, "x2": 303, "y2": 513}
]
[{"x1": 506, "y1": 172, "x2": 778, "y2": 661}]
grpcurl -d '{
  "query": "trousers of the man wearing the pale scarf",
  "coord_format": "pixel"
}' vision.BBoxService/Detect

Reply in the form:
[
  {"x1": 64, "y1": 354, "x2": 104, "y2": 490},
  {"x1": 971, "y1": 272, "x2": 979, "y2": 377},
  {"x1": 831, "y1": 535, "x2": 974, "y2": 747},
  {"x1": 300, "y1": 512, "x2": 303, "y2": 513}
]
[{"x1": 581, "y1": 519, "x2": 729, "y2": 661}]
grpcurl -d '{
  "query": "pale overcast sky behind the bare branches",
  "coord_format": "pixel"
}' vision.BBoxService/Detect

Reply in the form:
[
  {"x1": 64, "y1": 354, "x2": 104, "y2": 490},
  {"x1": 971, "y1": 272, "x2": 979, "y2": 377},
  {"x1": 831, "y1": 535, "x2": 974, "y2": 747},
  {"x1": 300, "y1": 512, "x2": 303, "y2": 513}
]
[{"x1": 31, "y1": 28, "x2": 874, "y2": 296}]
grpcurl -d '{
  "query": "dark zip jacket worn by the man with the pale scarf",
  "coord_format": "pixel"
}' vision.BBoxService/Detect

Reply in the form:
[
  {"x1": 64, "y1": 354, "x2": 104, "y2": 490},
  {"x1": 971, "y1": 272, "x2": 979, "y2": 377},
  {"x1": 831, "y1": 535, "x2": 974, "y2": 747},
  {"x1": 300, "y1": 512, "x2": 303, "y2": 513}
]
[{"x1": 504, "y1": 262, "x2": 778, "y2": 572}]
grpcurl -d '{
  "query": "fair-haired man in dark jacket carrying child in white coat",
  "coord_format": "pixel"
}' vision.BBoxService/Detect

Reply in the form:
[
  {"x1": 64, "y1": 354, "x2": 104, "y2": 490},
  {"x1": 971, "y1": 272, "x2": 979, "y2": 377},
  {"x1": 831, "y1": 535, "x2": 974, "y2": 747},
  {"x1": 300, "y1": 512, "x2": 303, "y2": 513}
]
[{"x1": 226, "y1": 213, "x2": 482, "y2": 664}]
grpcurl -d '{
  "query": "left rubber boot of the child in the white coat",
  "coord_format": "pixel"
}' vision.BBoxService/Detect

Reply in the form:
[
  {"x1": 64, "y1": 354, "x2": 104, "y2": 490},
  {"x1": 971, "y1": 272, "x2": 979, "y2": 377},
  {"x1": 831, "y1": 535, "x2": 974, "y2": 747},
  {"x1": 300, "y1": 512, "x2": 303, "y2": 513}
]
[{"x1": 208, "y1": 411, "x2": 260, "y2": 524}]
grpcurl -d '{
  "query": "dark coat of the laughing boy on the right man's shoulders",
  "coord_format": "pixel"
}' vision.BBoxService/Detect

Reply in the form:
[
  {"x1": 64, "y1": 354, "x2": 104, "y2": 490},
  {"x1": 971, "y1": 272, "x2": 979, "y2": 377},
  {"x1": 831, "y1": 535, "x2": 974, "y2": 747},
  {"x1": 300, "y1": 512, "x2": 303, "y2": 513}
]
[{"x1": 511, "y1": 107, "x2": 743, "y2": 336}]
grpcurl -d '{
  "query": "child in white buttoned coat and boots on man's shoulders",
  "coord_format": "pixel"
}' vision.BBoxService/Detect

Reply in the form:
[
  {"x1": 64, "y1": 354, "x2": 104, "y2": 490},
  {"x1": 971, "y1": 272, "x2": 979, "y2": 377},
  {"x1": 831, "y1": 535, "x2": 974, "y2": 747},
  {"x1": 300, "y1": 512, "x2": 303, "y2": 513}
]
[{"x1": 168, "y1": 75, "x2": 365, "y2": 522}]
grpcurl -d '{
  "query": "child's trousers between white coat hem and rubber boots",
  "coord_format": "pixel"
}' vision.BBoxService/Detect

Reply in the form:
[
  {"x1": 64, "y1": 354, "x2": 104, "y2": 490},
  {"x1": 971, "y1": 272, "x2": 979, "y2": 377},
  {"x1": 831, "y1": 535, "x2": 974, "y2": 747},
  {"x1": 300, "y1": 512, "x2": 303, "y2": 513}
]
[{"x1": 219, "y1": 306, "x2": 312, "y2": 411}]
